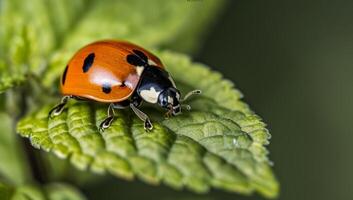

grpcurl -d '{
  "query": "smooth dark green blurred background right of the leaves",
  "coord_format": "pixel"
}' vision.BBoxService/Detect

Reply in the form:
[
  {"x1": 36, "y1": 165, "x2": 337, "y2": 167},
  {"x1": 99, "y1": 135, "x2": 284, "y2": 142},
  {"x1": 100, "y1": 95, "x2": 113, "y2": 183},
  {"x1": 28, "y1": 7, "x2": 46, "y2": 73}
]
[{"x1": 197, "y1": 0, "x2": 353, "y2": 200}]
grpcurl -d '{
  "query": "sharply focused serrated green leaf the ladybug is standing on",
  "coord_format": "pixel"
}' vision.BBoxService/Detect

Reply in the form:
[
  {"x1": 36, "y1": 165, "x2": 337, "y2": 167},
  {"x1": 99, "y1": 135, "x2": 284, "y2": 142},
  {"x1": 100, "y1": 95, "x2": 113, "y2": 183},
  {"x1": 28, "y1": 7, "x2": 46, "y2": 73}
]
[{"x1": 17, "y1": 51, "x2": 279, "y2": 198}]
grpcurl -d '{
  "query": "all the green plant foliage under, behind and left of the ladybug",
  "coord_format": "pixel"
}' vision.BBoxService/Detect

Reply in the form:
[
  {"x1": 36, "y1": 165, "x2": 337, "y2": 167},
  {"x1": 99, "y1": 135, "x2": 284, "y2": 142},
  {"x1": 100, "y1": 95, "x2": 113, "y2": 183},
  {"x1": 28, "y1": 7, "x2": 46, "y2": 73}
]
[{"x1": 0, "y1": 0, "x2": 279, "y2": 200}]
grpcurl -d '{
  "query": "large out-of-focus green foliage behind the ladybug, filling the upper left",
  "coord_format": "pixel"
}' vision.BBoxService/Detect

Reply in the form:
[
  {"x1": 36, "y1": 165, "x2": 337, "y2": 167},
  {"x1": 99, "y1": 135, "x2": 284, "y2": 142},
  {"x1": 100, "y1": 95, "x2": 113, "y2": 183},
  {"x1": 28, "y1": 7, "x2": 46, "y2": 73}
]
[{"x1": 0, "y1": 0, "x2": 223, "y2": 93}]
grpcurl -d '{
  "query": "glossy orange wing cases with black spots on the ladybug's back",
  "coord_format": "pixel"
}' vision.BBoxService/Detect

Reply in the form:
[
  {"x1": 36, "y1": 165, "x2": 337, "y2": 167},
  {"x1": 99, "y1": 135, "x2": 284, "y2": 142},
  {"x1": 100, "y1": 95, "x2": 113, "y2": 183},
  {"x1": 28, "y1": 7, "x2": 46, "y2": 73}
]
[{"x1": 61, "y1": 40, "x2": 164, "y2": 103}]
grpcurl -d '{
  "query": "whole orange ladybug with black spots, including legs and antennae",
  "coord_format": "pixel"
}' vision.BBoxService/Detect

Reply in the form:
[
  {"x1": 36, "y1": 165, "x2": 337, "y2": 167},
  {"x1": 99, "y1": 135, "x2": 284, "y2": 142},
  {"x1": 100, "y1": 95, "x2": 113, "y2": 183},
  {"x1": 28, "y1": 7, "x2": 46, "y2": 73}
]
[{"x1": 49, "y1": 40, "x2": 201, "y2": 131}]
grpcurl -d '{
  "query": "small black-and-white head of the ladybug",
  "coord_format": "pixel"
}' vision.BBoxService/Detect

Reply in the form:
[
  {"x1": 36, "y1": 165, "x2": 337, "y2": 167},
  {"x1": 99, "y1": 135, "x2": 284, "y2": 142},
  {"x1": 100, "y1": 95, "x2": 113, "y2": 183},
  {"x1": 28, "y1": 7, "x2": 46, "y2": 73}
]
[{"x1": 158, "y1": 87, "x2": 181, "y2": 115}]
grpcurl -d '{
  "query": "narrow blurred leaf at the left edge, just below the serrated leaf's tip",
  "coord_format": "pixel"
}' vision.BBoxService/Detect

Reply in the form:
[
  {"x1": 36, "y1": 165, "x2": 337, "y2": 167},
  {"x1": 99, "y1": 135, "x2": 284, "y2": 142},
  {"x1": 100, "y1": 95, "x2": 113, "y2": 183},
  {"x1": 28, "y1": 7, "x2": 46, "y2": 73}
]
[{"x1": 0, "y1": 112, "x2": 30, "y2": 185}]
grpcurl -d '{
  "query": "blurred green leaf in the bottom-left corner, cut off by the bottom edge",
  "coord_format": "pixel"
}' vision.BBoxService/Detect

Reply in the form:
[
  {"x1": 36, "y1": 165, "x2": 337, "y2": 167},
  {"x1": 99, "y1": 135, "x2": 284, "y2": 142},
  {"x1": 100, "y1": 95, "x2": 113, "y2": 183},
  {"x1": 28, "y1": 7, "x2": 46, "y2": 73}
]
[{"x1": 0, "y1": 183, "x2": 86, "y2": 200}]
